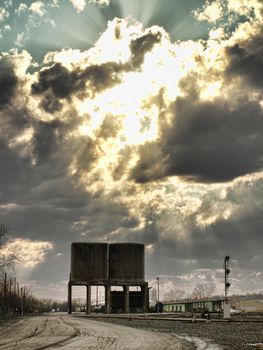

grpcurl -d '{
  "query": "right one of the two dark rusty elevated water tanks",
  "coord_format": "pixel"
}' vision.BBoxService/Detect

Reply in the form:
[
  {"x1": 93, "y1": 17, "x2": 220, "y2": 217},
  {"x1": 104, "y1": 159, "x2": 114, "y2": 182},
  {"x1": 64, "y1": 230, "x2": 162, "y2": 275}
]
[{"x1": 109, "y1": 243, "x2": 144, "y2": 282}]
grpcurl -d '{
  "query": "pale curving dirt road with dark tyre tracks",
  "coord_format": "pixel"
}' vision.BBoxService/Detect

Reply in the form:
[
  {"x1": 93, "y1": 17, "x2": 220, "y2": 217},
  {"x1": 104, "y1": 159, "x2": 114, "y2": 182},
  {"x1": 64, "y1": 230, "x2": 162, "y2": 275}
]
[{"x1": 0, "y1": 315, "x2": 194, "y2": 350}]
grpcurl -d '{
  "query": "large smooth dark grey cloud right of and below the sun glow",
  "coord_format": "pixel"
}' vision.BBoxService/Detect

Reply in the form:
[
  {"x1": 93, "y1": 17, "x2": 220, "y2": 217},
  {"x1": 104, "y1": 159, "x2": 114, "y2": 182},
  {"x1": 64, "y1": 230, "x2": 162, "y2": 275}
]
[{"x1": 132, "y1": 97, "x2": 263, "y2": 182}]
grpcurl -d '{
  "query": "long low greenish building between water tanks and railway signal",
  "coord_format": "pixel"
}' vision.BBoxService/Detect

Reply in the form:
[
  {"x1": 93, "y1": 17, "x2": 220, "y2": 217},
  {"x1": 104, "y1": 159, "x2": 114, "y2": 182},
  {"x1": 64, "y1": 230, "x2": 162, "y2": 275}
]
[{"x1": 164, "y1": 299, "x2": 224, "y2": 312}]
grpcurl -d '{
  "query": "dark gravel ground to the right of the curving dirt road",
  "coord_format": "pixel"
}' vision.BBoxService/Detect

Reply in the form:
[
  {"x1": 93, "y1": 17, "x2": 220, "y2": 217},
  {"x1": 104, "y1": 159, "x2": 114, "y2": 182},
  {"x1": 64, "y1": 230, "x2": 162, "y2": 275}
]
[{"x1": 96, "y1": 319, "x2": 263, "y2": 350}]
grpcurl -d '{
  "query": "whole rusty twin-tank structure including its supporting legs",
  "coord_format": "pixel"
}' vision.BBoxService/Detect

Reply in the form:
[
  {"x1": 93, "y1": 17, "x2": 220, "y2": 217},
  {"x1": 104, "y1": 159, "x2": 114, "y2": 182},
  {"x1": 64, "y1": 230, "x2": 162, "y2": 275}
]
[{"x1": 68, "y1": 242, "x2": 149, "y2": 314}]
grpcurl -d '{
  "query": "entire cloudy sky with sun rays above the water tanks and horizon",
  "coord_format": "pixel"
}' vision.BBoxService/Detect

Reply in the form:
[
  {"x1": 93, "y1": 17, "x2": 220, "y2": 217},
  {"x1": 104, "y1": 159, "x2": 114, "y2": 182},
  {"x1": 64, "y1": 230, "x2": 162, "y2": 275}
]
[{"x1": 0, "y1": 0, "x2": 263, "y2": 298}]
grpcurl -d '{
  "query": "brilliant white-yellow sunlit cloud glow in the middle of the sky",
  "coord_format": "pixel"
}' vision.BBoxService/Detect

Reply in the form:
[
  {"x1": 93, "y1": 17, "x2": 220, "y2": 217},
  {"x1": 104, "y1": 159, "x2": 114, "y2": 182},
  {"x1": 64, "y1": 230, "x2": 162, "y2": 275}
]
[{"x1": 58, "y1": 13, "x2": 241, "y2": 191}]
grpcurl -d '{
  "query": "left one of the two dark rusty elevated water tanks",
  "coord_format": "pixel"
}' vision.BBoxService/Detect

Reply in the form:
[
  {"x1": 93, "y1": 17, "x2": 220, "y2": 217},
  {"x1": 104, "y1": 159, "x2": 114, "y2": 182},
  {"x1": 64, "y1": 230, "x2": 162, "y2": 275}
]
[{"x1": 71, "y1": 242, "x2": 108, "y2": 284}]
